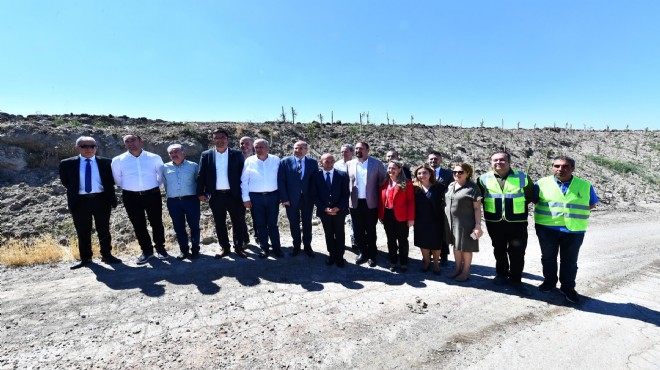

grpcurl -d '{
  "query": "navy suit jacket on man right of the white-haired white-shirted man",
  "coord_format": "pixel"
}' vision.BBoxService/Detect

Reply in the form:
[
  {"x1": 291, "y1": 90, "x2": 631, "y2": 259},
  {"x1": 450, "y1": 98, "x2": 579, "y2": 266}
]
[{"x1": 277, "y1": 156, "x2": 319, "y2": 208}]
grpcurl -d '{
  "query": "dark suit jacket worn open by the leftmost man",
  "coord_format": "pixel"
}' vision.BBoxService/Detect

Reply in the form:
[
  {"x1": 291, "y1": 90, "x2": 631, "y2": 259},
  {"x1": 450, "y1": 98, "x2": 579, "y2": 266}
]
[{"x1": 60, "y1": 155, "x2": 117, "y2": 211}]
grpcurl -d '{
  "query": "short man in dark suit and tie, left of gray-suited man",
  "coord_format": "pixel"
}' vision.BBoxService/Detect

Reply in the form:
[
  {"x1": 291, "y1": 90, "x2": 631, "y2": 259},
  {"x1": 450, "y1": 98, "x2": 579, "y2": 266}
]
[{"x1": 312, "y1": 153, "x2": 350, "y2": 267}]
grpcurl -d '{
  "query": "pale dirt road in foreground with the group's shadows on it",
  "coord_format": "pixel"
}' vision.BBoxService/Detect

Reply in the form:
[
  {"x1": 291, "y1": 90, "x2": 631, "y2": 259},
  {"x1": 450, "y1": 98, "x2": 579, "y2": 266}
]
[{"x1": 0, "y1": 206, "x2": 660, "y2": 369}]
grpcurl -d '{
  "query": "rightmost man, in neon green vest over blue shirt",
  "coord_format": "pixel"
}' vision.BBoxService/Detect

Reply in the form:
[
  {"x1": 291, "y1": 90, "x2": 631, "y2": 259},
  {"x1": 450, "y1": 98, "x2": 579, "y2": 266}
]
[{"x1": 534, "y1": 156, "x2": 598, "y2": 303}]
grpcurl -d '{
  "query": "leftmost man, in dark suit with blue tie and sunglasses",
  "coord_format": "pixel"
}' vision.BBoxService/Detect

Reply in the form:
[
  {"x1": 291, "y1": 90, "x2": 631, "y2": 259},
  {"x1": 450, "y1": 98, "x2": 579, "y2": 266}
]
[{"x1": 60, "y1": 136, "x2": 121, "y2": 270}]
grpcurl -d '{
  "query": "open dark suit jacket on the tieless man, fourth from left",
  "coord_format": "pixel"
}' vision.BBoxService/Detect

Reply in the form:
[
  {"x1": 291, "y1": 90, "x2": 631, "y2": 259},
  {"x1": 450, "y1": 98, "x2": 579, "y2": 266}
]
[{"x1": 197, "y1": 147, "x2": 245, "y2": 199}]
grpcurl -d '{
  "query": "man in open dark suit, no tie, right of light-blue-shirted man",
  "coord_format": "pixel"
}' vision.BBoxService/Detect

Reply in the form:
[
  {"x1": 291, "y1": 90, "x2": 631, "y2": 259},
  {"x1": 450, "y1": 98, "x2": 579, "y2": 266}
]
[{"x1": 197, "y1": 129, "x2": 247, "y2": 258}]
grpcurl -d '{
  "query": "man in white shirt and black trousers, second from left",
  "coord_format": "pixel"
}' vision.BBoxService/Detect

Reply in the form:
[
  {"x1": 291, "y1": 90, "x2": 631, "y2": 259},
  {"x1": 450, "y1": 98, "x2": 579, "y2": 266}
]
[{"x1": 111, "y1": 134, "x2": 169, "y2": 265}]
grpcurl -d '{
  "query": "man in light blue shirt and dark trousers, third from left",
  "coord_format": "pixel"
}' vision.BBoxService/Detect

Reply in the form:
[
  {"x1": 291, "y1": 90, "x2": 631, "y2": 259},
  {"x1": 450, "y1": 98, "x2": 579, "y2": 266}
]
[{"x1": 161, "y1": 144, "x2": 200, "y2": 260}]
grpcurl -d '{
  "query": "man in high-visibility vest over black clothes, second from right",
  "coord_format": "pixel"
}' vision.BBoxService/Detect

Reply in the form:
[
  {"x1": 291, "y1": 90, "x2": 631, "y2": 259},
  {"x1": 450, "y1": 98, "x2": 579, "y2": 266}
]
[{"x1": 477, "y1": 151, "x2": 534, "y2": 295}]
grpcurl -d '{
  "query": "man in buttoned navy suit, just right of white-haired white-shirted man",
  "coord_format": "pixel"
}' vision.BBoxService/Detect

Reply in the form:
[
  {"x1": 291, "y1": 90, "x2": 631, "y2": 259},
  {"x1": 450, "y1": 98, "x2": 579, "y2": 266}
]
[{"x1": 277, "y1": 141, "x2": 319, "y2": 257}]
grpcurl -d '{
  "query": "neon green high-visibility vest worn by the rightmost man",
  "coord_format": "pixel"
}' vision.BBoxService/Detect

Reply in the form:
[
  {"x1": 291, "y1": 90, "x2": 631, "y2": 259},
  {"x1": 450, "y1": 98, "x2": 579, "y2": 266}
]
[{"x1": 534, "y1": 176, "x2": 591, "y2": 231}]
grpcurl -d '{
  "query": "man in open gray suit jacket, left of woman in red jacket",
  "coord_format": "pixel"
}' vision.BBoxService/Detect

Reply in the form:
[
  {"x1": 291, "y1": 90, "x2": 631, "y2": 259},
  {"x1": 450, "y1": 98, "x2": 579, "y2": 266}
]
[{"x1": 347, "y1": 142, "x2": 385, "y2": 267}]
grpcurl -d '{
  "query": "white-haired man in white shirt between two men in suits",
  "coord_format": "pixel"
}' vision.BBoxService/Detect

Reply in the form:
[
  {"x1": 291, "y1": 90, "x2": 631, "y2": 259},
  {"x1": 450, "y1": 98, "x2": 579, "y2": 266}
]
[{"x1": 241, "y1": 139, "x2": 284, "y2": 258}]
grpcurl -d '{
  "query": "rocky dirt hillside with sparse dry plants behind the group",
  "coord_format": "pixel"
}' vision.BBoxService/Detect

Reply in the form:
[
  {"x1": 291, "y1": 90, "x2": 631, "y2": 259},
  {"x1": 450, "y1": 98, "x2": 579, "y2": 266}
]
[{"x1": 0, "y1": 113, "x2": 660, "y2": 246}]
